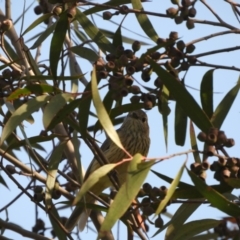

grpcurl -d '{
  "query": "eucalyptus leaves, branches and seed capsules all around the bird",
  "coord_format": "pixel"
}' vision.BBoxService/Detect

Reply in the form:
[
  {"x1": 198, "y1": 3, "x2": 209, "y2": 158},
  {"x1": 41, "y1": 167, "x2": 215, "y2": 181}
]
[{"x1": 0, "y1": 0, "x2": 240, "y2": 240}]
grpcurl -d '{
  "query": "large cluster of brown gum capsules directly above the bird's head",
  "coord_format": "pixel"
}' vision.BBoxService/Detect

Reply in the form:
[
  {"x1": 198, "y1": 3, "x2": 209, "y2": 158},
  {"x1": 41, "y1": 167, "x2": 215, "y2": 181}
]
[{"x1": 96, "y1": 41, "x2": 161, "y2": 110}]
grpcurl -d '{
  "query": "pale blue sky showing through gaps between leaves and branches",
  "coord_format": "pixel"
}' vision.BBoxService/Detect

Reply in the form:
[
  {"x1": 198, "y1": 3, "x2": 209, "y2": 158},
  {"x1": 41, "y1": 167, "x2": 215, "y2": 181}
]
[{"x1": 0, "y1": 0, "x2": 240, "y2": 239}]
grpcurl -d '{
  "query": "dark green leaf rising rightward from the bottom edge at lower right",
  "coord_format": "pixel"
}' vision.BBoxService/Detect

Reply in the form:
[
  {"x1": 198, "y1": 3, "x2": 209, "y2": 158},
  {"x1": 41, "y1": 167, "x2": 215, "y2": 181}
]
[{"x1": 172, "y1": 219, "x2": 221, "y2": 240}]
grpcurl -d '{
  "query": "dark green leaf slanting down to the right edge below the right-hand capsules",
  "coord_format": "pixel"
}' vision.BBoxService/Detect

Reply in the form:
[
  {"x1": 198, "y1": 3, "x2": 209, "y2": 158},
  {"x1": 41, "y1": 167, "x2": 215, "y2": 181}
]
[{"x1": 187, "y1": 169, "x2": 240, "y2": 217}]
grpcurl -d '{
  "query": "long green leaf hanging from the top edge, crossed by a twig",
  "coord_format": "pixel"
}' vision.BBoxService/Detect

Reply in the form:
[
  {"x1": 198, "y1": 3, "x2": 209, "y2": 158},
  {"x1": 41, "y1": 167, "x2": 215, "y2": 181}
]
[{"x1": 131, "y1": 0, "x2": 159, "y2": 42}]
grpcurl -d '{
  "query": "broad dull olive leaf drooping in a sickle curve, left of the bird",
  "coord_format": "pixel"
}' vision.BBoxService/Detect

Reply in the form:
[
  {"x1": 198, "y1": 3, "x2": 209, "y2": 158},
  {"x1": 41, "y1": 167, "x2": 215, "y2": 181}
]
[{"x1": 43, "y1": 93, "x2": 73, "y2": 129}]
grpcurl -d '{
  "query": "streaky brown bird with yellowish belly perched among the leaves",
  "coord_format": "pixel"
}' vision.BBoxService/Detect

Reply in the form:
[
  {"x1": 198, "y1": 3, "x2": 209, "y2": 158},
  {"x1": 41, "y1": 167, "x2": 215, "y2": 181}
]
[{"x1": 65, "y1": 110, "x2": 150, "y2": 231}]
